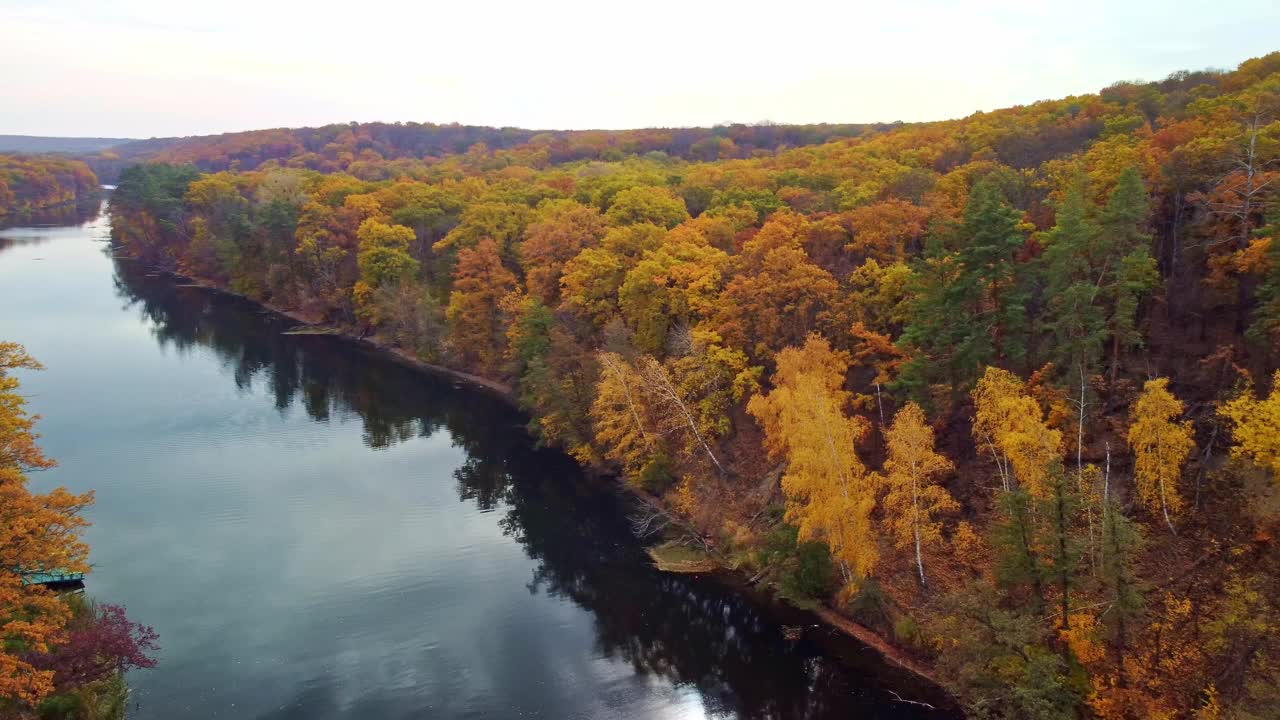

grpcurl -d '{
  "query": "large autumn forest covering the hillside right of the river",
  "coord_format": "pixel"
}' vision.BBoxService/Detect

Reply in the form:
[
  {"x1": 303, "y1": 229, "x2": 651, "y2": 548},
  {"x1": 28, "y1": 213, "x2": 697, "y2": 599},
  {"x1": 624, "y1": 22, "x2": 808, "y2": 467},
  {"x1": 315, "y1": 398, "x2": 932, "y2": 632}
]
[{"x1": 104, "y1": 53, "x2": 1280, "y2": 719}]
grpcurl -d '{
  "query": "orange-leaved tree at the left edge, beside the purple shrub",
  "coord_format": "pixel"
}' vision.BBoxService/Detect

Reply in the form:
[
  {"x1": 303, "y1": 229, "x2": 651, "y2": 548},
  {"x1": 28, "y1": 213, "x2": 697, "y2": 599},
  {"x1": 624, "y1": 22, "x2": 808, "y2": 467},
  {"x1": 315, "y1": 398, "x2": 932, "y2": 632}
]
[{"x1": 0, "y1": 342, "x2": 93, "y2": 707}]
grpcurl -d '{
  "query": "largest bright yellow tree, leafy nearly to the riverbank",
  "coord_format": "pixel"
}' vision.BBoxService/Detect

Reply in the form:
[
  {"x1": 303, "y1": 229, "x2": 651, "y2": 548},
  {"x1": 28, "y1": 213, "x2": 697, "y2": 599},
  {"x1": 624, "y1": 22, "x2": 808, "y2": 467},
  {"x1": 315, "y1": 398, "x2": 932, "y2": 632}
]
[{"x1": 748, "y1": 334, "x2": 878, "y2": 589}]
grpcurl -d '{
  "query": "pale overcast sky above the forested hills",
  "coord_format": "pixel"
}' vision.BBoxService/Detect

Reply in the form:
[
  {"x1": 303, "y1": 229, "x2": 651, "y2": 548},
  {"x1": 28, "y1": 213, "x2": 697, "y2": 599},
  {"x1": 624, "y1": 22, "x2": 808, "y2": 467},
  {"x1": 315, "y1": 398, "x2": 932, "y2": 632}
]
[{"x1": 0, "y1": 0, "x2": 1280, "y2": 137}]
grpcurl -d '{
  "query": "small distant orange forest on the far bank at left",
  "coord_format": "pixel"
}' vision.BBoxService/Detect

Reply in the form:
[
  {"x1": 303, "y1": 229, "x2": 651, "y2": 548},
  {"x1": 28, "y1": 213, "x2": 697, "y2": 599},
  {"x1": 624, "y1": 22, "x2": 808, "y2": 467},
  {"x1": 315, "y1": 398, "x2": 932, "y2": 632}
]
[{"x1": 0, "y1": 155, "x2": 97, "y2": 217}]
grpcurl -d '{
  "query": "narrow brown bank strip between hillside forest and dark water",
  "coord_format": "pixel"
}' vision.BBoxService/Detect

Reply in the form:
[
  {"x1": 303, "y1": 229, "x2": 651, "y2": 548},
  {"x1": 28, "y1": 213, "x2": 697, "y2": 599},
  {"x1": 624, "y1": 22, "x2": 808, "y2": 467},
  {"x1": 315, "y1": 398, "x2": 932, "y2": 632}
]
[{"x1": 129, "y1": 256, "x2": 954, "y2": 707}]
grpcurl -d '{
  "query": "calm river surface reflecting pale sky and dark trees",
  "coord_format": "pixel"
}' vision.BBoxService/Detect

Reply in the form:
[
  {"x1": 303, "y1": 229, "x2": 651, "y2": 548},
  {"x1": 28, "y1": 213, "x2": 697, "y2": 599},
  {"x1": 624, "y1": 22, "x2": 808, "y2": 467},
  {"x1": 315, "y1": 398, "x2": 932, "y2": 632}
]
[{"x1": 0, "y1": 199, "x2": 941, "y2": 720}]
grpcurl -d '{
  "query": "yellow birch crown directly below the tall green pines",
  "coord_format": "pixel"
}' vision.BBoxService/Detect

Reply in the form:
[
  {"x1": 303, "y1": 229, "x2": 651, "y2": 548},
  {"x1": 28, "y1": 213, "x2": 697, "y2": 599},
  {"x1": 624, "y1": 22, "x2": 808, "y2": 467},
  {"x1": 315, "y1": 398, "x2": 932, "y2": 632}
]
[{"x1": 972, "y1": 368, "x2": 1062, "y2": 497}]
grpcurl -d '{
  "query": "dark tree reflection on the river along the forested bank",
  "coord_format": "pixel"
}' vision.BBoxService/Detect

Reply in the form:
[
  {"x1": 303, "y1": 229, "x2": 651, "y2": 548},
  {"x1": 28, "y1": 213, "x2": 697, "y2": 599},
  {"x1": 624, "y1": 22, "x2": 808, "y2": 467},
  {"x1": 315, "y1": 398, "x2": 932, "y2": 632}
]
[{"x1": 115, "y1": 254, "x2": 957, "y2": 719}]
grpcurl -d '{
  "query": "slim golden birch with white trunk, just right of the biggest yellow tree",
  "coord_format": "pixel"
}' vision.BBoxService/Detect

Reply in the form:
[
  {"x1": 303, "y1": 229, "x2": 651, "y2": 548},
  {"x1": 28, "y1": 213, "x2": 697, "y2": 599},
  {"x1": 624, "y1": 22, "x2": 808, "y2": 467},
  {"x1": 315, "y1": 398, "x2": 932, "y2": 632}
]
[{"x1": 884, "y1": 402, "x2": 960, "y2": 585}]
